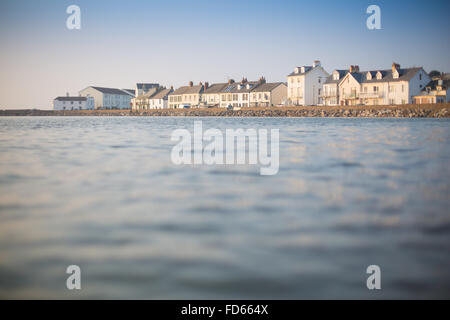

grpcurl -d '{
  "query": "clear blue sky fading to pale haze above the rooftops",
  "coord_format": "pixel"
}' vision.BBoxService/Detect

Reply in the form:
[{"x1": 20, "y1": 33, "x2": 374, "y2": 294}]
[{"x1": 0, "y1": 0, "x2": 450, "y2": 109}]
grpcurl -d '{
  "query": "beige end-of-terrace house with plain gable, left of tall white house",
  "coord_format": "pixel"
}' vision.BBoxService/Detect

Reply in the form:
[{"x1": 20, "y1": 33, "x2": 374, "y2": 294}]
[{"x1": 250, "y1": 82, "x2": 287, "y2": 107}]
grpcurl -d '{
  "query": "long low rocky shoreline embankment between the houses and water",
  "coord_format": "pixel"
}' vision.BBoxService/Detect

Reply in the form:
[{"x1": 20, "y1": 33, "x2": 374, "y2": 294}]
[{"x1": 0, "y1": 103, "x2": 450, "y2": 118}]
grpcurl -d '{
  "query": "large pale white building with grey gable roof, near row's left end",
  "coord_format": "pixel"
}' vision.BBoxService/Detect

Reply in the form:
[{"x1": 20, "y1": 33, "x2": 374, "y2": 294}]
[{"x1": 80, "y1": 86, "x2": 134, "y2": 109}]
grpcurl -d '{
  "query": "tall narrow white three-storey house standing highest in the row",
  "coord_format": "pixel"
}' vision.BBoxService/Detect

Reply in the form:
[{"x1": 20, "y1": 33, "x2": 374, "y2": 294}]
[{"x1": 288, "y1": 60, "x2": 329, "y2": 106}]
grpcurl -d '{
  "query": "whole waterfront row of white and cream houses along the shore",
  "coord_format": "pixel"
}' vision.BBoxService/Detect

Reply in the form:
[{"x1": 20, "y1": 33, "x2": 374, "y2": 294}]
[{"x1": 54, "y1": 61, "x2": 450, "y2": 111}]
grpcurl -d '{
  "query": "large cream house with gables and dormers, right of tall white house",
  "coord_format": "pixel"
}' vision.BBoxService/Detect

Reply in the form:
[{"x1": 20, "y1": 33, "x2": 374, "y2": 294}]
[{"x1": 339, "y1": 63, "x2": 430, "y2": 105}]
